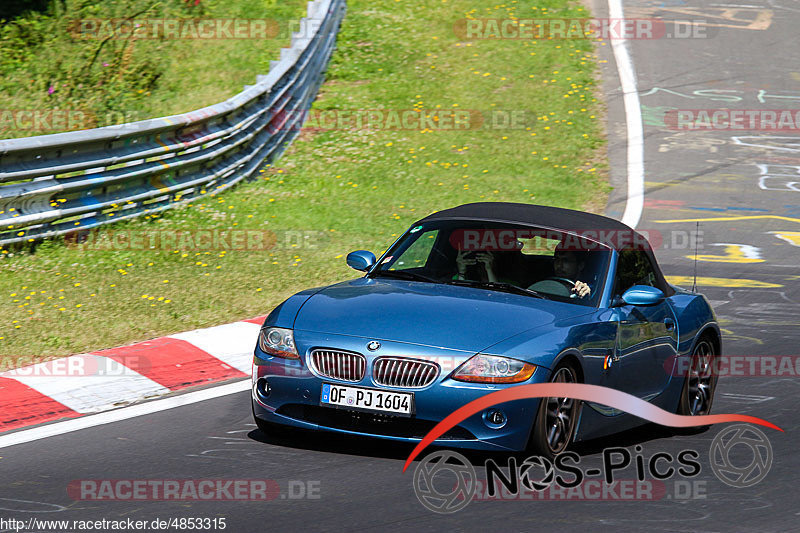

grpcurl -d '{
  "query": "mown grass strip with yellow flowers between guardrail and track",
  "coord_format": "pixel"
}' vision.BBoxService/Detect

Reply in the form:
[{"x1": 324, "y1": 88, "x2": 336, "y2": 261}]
[{"x1": 0, "y1": 0, "x2": 609, "y2": 362}]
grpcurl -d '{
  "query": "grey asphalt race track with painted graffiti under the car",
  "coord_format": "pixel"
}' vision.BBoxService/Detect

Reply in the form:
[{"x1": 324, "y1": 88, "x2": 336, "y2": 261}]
[{"x1": 0, "y1": 0, "x2": 800, "y2": 532}]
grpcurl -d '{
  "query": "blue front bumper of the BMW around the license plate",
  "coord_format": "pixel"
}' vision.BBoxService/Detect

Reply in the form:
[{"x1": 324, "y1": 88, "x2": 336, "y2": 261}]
[{"x1": 251, "y1": 332, "x2": 550, "y2": 451}]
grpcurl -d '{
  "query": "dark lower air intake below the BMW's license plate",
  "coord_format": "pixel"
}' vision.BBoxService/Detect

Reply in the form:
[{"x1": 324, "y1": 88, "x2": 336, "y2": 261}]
[{"x1": 276, "y1": 403, "x2": 476, "y2": 440}]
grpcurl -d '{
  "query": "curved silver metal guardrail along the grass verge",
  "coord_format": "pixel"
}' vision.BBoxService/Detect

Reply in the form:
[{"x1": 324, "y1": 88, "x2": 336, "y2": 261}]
[{"x1": 0, "y1": 0, "x2": 346, "y2": 246}]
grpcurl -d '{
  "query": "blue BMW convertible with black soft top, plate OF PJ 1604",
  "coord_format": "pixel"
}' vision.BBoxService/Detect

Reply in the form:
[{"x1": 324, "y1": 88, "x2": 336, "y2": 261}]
[{"x1": 252, "y1": 202, "x2": 721, "y2": 457}]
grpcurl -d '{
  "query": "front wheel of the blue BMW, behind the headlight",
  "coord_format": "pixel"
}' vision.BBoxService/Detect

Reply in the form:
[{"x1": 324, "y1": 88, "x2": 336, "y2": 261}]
[{"x1": 528, "y1": 363, "x2": 580, "y2": 460}]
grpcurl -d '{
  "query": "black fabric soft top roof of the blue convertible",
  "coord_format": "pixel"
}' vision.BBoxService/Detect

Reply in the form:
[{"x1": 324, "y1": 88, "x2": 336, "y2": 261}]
[{"x1": 414, "y1": 202, "x2": 674, "y2": 295}]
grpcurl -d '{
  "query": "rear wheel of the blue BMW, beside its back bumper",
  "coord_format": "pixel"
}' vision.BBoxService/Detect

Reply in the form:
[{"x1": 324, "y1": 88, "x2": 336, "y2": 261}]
[{"x1": 677, "y1": 335, "x2": 718, "y2": 416}]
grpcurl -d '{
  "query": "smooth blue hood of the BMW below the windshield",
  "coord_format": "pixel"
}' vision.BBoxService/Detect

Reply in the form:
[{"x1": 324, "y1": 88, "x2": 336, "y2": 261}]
[{"x1": 294, "y1": 278, "x2": 593, "y2": 353}]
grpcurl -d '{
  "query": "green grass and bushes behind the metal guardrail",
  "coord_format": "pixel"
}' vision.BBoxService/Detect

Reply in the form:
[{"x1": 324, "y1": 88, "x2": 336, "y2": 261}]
[{"x1": 0, "y1": 0, "x2": 306, "y2": 138}]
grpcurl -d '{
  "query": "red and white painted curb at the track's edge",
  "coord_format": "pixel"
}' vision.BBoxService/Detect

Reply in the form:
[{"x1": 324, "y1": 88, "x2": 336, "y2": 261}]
[{"x1": 0, "y1": 317, "x2": 265, "y2": 433}]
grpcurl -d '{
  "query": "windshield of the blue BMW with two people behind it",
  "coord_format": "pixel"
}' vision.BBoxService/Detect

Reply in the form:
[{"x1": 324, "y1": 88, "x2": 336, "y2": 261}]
[{"x1": 370, "y1": 220, "x2": 611, "y2": 306}]
